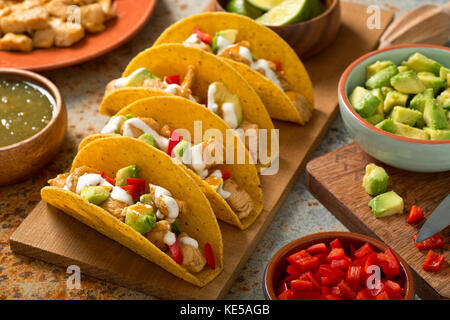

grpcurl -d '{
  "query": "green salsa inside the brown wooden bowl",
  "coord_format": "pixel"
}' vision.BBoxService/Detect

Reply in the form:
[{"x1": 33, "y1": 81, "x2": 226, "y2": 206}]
[{"x1": 0, "y1": 79, "x2": 55, "y2": 148}]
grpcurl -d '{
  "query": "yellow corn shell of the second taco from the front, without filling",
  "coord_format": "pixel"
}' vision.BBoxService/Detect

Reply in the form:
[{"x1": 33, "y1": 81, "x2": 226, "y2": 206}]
[{"x1": 79, "y1": 97, "x2": 263, "y2": 229}]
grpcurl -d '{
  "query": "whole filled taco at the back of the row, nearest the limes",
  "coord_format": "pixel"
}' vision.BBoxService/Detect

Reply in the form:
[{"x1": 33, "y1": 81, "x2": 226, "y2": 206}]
[{"x1": 154, "y1": 12, "x2": 314, "y2": 124}]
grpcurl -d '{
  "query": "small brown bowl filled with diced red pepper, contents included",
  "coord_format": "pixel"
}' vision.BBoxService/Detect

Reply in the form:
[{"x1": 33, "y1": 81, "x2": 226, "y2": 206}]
[{"x1": 264, "y1": 232, "x2": 414, "y2": 300}]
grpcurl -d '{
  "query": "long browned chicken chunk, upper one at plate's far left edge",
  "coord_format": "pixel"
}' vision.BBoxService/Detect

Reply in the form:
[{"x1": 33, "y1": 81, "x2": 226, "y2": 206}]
[{"x1": 0, "y1": 7, "x2": 48, "y2": 33}]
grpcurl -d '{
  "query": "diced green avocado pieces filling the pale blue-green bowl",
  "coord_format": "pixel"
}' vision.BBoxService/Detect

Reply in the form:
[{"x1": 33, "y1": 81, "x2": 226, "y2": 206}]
[{"x1": 349, "y1": 53, "x2": 450, "y2": 140}]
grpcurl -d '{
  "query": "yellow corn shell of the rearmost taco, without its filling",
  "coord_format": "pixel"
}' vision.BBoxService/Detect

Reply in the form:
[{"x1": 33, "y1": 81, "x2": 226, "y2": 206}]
[{"x1": 154, "y1": 12, "x2": 314, "y2": 124}]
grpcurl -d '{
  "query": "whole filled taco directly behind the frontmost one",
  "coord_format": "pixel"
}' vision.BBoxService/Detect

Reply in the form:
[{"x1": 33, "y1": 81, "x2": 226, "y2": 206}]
[{"x1": 80, "y1": 97, "x2": 263, "y2": 229}]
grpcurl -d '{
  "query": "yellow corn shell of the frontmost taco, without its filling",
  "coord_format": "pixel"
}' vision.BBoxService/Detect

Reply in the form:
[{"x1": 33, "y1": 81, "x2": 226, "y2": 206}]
[{"x1": 41, "y1": 137, "x2": 223, "y2": 287}]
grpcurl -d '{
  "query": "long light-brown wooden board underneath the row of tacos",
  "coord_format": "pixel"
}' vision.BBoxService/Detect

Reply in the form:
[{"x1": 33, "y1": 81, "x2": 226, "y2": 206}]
[{"x1": 10, "y1": 3, "x2": 393, "y2": 299}]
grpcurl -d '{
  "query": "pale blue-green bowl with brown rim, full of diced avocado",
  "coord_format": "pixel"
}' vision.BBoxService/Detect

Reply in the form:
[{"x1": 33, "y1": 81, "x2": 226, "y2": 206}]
[{"x1": 338, "y1": 45, "x2": 450, "y2": 172}]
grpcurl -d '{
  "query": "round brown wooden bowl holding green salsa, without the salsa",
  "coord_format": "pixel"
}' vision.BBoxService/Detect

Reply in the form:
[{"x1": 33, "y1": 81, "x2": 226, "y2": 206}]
[{"x1": 0, "y1": 68, "x2": 67, "y2": 186}]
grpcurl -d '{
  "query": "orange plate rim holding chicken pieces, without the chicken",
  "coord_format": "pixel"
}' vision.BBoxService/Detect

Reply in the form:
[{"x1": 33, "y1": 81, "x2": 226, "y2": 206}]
[{"x1": 0, "y1": 0, "x2": 157, "y2": 71}]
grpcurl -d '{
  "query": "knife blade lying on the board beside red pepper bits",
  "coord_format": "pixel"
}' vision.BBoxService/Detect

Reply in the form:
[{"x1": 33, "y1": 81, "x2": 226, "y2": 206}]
[{"x1": 416, "y1": 194, "x2": 450, "y2": 243}]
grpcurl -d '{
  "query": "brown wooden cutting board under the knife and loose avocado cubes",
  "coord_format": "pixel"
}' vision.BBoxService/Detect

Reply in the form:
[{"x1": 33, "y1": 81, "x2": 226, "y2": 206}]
[{"x1": 306, "y1": 143, "x2": 450, "y2": 299}]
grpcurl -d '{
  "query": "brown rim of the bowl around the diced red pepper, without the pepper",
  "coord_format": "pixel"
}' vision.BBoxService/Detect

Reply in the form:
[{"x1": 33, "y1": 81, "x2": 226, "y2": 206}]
[{"x1": 263, "y1": 232, "x2": 414, "y2": 300}]
